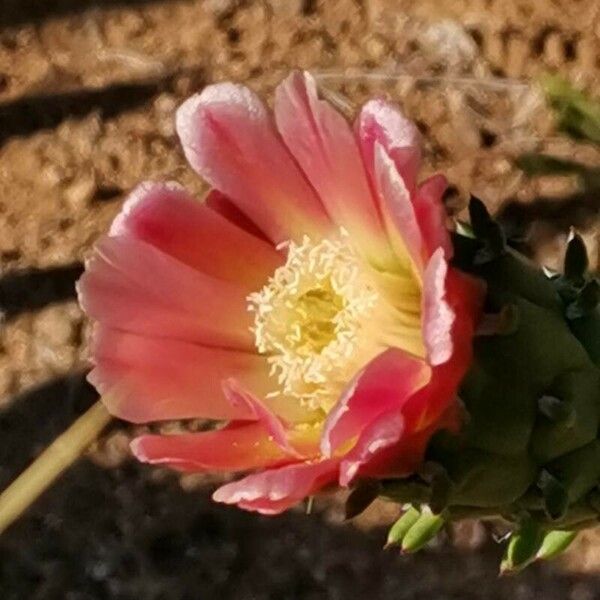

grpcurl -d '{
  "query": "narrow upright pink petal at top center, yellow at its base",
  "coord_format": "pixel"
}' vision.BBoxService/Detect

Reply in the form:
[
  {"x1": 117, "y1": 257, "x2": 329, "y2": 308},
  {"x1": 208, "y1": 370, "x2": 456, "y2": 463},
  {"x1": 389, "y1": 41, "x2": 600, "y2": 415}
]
[{"x1": 275, "y1": 72, "x2": 392, "y2": 265}]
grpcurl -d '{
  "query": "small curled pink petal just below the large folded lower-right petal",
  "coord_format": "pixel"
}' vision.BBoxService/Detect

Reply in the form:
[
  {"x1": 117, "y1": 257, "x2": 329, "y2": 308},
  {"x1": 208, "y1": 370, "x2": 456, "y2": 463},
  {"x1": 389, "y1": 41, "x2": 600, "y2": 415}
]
[{"x1": 339, "y1": 410, "x2": 404, "y2": 486}]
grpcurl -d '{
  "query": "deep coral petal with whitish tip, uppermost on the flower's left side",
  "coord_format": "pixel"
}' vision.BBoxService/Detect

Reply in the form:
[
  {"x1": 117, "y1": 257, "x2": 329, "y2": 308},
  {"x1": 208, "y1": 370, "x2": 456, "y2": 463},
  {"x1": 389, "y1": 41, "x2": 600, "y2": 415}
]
[{"x1": 110, "y1": 182, "x2": 281, "y2": 290}]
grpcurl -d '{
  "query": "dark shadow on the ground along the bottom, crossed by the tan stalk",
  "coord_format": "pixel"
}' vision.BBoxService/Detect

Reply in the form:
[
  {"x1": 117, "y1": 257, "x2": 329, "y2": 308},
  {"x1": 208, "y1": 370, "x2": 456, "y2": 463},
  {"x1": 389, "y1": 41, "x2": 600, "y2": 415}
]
[{"x1": 0, "y1": 374, "x2": 600, "y2": 600}]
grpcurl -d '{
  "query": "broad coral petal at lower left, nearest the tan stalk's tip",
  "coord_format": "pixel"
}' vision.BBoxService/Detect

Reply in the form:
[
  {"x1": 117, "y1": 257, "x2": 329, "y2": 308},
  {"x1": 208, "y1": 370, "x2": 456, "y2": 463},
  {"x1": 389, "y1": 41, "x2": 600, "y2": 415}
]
[{"x1": 89, "y1": 327, "x2": 272, "y2": 423}]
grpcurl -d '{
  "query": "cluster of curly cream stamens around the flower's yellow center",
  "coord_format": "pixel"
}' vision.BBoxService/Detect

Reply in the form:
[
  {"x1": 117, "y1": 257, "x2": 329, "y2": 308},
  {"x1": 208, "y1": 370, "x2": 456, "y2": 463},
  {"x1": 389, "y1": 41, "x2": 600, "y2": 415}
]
[{"x1": 248, "y1": 231, "x2": 392, "y2": 412}]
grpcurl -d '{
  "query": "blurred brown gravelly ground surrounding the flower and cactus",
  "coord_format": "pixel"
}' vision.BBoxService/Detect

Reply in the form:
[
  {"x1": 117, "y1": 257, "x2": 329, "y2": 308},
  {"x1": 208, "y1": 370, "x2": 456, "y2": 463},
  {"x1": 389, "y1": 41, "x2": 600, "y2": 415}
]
[{"x1": 0, "y1": 0, "x2": 600, "y2": 600}]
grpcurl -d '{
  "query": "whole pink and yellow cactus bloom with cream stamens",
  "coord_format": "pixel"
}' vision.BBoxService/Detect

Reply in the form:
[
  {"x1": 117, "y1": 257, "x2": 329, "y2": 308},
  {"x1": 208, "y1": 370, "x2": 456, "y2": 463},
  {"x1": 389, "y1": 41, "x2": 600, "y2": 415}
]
[{"x1": 79, "y1": 73, "x2": 481, "y2": 514}]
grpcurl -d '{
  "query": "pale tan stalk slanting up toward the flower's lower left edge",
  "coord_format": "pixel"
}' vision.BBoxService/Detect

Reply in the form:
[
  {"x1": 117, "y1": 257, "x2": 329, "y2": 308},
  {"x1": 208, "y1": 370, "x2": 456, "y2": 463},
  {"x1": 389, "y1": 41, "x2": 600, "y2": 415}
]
[{"x1": 0, "y1": 401, "x2": 112, "y2": 533}]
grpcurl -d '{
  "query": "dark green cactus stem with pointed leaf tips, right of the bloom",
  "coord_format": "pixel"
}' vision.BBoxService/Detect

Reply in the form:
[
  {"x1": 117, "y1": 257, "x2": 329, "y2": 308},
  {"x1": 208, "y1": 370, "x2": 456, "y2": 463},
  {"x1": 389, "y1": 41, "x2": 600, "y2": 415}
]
[{"x1": 359, "y1": 199, "x2": 600, "y2": 572}]
